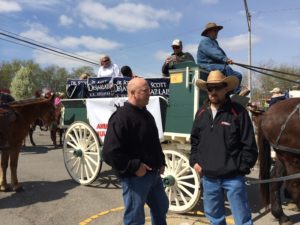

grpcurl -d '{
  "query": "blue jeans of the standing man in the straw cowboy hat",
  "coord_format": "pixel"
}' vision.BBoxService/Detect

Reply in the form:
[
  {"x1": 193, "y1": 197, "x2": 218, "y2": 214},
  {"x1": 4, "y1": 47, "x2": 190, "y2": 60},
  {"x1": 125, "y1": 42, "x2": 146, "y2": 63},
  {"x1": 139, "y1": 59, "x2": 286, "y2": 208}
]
[{"x1": 202, "y1": 176, "x2": 253, "y2": 225}]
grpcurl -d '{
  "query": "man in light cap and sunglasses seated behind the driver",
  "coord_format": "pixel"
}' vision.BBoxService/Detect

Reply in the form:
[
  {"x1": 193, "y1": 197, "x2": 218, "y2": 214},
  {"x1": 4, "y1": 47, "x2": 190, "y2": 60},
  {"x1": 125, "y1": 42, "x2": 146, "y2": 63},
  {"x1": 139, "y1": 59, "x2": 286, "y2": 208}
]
[{"x1": 161, "y1": 39, "x2": 195, "y2": 77}]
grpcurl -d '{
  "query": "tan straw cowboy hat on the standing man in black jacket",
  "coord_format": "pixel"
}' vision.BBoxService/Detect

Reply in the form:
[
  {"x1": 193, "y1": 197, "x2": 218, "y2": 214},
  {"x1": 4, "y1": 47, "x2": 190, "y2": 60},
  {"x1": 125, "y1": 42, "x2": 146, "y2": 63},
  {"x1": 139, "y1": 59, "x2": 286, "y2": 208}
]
[{"x1": 196, "y1": 70, "x2": 239, "y2": 91}]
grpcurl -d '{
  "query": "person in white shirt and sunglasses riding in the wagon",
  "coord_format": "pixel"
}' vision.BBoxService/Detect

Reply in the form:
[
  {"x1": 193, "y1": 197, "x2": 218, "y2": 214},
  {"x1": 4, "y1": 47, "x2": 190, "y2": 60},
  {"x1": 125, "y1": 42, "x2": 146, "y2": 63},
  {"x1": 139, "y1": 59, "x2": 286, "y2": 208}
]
[{"x1": 97, "y1": 55, "x2": 123, "y2": 78}]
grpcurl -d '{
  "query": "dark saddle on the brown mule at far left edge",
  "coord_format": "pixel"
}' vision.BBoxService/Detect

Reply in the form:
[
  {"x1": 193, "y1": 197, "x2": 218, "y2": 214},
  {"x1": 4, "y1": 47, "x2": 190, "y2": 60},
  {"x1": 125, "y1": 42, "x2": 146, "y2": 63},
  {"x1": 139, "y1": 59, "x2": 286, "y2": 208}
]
[{"x1": 0, "y1": 93, "x2": 15, "y2": 150}]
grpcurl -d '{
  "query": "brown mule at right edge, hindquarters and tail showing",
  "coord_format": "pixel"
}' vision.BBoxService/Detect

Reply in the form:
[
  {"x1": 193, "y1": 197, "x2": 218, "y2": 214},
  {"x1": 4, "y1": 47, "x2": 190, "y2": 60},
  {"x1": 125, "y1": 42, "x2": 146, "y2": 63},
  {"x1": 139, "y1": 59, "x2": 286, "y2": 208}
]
[{"x1": 253, "y1": 98, "x2": 300, "y2": 225}]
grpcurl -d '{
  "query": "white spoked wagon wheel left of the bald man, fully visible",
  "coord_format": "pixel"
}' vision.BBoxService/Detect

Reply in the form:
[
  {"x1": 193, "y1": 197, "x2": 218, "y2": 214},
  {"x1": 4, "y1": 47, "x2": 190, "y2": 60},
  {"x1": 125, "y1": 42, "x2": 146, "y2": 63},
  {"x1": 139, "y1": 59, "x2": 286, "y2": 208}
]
[{"x1": 63, "y1": 122, "x2": 102, "y2": 185}]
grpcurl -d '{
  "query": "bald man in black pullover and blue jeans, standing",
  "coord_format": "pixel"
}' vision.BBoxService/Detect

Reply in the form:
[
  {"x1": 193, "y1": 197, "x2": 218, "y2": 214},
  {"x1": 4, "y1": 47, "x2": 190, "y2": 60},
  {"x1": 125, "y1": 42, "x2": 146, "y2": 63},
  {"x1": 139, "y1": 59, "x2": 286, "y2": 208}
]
[{"x1": 102, "y1": 78, "x2": 169, "y2": 225}]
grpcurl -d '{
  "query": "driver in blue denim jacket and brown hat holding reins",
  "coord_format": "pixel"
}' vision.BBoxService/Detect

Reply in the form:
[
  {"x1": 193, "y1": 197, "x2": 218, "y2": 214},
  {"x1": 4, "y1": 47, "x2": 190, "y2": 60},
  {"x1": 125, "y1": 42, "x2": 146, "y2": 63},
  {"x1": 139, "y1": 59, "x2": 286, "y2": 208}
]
[{"x1": 197, "y1": 23, "x2": 250, "y2": 96}]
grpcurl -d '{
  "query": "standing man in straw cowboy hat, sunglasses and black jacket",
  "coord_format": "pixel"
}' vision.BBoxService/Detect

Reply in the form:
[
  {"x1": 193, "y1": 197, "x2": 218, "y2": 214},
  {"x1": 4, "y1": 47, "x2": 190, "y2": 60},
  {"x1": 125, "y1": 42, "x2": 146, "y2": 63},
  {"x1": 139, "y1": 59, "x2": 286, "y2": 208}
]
[{"x1": 190, "y1": 70, "x2": 257, "y2": 225}]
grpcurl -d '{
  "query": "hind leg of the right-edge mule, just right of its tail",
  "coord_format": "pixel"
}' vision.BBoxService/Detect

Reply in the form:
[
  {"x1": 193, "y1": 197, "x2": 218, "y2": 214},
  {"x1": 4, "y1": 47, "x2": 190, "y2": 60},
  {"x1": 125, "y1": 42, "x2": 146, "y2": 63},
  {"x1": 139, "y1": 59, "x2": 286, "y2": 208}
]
[{"x1": 270, "y1": 160, "x2": 293, "y2": 225}]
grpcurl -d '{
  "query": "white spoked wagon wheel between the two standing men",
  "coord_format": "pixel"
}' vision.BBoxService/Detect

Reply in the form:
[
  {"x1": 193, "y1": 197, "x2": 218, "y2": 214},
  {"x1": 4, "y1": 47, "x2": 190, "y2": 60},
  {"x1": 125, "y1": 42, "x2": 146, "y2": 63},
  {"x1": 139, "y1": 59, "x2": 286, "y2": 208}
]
[{"x1": 162, "y1": 150, "x2": 200, "y2": 213}]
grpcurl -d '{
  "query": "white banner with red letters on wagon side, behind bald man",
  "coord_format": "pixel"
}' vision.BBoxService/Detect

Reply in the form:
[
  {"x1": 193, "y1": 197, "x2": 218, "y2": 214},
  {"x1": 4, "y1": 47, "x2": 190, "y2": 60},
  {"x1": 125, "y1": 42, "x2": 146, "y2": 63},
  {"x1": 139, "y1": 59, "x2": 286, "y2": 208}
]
[{"x1": 86, "y1": 96, "x2": 163, "y2": 142}]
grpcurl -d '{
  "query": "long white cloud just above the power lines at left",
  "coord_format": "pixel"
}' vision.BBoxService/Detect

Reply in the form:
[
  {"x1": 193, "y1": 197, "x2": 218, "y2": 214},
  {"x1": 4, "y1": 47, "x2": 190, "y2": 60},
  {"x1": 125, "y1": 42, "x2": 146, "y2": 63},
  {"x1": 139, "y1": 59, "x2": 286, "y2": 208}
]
[{"x1": 20, "y1": 24, "x2": 121, "y2": 51}]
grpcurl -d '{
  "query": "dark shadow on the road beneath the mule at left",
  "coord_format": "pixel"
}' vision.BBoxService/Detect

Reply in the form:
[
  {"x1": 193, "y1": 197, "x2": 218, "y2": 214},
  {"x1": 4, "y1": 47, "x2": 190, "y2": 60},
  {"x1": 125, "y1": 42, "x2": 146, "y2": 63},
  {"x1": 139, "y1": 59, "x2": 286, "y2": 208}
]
[{"x1": 0, "y1": 180, "x2": 78, "y2": 209}]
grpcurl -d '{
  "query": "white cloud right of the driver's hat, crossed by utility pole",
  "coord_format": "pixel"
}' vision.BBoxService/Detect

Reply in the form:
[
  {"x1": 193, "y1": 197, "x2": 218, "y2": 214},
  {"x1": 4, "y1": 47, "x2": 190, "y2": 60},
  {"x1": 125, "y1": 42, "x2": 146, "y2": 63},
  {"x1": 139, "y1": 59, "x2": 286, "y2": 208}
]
[{"x1": 219, "y1": 34, "x2": 260, "y2": 51}]
